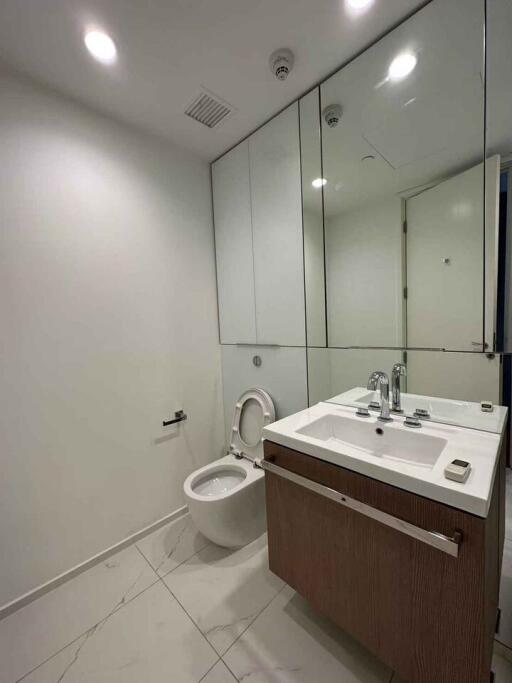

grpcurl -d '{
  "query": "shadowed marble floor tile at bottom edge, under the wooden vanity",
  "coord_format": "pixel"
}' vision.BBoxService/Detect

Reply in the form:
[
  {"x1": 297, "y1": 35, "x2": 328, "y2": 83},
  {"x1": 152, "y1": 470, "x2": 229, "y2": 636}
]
[{"x1": 224, "y1": 586, "x2": 391, "y2": 683}]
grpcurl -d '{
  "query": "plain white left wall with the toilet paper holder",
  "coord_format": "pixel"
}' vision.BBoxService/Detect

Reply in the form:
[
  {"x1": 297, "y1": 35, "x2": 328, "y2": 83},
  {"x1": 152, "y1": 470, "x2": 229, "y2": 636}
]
[{"x1": 0, "y1": 67, "x2": 223, "y2": 604}]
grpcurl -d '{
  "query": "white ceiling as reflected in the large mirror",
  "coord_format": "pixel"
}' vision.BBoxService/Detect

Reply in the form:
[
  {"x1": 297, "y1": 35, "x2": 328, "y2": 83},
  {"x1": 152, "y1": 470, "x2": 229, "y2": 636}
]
[{"x1": 318, "y1": 0, "x2": 486, "y2": 217}]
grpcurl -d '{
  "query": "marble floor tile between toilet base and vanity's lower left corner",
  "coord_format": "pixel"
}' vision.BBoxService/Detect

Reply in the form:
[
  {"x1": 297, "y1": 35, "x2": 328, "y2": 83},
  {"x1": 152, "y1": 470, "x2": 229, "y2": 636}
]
[{"x1": 164, "y1": 535, "x2": 284, "y2": 655}]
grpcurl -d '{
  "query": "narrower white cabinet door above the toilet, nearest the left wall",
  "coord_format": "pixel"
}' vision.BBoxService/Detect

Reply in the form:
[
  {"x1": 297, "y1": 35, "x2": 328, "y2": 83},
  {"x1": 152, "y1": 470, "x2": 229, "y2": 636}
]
[{"x1": 212, "y1": 141, "x2": 256, "y2": 344}]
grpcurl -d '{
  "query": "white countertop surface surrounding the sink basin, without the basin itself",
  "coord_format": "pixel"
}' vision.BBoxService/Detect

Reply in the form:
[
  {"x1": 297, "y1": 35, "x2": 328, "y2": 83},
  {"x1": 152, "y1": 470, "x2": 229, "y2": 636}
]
[{"x1": 263, "y1": 402, "x2": 502, "y2": 517}]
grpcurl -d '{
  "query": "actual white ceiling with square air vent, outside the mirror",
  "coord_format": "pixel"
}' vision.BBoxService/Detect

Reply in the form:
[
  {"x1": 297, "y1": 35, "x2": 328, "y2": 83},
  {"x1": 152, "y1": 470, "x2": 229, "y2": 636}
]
[{"x1": 0, "y1": 0, "x2": 425, "y2": 160}]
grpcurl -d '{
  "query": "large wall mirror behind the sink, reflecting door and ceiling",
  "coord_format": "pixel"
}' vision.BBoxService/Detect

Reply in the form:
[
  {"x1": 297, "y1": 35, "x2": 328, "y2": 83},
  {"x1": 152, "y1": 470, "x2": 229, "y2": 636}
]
[{"x1": 300, "y1": 0, "x2": 512, "y2": 416}]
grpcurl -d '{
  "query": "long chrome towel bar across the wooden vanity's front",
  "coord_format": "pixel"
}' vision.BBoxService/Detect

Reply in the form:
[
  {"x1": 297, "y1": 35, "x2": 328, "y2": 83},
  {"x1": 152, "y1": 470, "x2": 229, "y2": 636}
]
[{"x1": 258, "y1": 460, "x2": 462, "y2": 557}]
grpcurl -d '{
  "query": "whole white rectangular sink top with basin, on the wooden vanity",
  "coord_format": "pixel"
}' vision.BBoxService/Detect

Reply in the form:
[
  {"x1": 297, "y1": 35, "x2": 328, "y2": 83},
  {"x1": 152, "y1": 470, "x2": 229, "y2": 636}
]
[{"x1": 263, "y1": 400, "x2": 503, "y2": 517}]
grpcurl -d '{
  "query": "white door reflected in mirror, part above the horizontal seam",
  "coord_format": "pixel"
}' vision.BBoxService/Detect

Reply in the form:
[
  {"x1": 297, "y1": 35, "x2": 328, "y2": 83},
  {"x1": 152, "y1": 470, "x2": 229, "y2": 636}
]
[{"x1": 406, "y1": 164, "x2": 484, "y2": 351}]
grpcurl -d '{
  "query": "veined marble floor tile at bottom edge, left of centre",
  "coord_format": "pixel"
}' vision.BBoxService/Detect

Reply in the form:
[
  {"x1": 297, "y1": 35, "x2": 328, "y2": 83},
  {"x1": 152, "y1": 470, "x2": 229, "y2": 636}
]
[{"x1": 19, "y1": 581, "x2": 217, "y2": 683}]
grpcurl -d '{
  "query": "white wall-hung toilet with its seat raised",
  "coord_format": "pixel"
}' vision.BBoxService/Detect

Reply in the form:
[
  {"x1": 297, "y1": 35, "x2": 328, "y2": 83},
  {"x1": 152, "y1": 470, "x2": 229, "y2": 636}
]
[{"x1": 183, "y1": 389, "x2": 275, "y2": 548}]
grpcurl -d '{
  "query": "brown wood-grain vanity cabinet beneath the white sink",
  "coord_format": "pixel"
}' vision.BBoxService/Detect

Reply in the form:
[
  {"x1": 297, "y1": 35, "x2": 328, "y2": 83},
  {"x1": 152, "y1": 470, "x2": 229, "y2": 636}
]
[{"x1": 263, "y1": 440, "x2": 505, "y2": 683}]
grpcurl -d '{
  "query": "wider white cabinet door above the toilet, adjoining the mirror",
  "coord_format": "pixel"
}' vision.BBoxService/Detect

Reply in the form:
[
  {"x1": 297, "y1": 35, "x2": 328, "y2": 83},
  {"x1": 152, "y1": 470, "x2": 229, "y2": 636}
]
[{"x1": 249, "y1": 103, "x2": 305, "y2": 346}]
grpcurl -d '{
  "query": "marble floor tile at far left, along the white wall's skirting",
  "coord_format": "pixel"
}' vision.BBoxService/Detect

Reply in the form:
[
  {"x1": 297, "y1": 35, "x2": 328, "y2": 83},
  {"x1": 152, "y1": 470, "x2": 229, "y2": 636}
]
[{"x1": 0, "y1": 546, "x2": 158, "y2": 683}]
